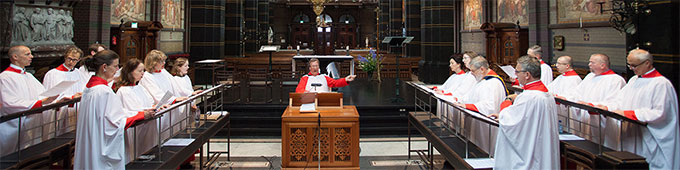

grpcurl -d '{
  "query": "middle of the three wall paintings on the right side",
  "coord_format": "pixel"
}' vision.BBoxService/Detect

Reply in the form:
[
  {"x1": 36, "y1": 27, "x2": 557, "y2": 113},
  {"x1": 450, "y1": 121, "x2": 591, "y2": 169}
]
[{"x1": 496, "y1": 0, "x2": 529, "y2": 26}]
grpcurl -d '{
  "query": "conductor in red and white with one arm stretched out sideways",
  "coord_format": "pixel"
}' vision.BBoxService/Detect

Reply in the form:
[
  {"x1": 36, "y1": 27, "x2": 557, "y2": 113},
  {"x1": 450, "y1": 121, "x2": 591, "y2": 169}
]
[{"x1": 295, "y1": 58, "x2": 356, "y2": 93}]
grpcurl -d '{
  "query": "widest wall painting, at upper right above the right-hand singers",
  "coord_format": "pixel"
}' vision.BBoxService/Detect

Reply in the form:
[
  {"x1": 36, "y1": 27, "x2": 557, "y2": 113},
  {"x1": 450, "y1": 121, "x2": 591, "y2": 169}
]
[{"x1": 556, "y1": 0, "x2": 612, "y2": 24}]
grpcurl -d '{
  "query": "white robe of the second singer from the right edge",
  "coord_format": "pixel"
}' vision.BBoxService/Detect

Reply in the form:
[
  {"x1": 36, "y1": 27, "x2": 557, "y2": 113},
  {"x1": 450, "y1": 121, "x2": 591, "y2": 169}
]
[{"x1": 564, "y1": 70, "x2": 626, "y2": 150}]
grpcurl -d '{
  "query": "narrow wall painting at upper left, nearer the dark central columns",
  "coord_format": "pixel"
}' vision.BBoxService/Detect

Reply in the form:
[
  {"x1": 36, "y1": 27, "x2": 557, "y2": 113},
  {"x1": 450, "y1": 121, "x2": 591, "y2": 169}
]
[{"x1": 161, "y1": 0, "x2": 184, "y2": 29}]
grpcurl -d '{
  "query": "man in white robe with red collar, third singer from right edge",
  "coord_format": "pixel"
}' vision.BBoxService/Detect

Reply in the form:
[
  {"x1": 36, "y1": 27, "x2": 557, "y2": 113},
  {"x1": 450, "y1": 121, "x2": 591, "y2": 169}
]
[{"x1": 541, "y1": 56, "x2": 581, "y2": 131}]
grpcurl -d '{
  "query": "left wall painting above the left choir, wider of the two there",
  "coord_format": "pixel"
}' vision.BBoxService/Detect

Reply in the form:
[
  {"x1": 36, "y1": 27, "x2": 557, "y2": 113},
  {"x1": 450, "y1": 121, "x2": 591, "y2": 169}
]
[{"x1": 111, "y1": 0, "x2": 146, "y2": 25}]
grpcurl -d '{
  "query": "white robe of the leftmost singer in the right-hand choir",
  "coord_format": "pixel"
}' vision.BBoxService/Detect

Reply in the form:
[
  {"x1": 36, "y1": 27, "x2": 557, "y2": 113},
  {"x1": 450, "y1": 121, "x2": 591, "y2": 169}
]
[{"x1": 436, "y1": 71, "x2": 477, "y2": 126}]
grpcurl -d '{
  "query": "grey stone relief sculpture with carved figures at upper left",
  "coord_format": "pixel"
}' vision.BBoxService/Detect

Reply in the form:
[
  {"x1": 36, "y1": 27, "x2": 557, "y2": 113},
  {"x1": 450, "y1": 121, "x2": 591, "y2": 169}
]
[{"x1": 12, "y1": 7, "x2": 74, "y2": 45}]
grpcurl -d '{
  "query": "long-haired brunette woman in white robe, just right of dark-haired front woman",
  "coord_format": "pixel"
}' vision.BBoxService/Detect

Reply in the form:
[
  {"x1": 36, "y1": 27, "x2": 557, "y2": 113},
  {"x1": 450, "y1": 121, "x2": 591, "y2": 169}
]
[{"x1": 113, "y1": 59, "x2": 158, "y2": 162}]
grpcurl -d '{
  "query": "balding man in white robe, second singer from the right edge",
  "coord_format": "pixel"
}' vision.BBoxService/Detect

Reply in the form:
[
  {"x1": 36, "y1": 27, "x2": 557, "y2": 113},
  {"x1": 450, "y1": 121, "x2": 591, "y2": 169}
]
[{"x1": 558, "y1": 54, "x2": 626, "y2": 149}]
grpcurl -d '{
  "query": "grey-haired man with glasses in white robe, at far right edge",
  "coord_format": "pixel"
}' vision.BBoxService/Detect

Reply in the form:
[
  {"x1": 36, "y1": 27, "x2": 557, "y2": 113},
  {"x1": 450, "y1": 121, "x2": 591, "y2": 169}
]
[{"x1": 598, "y1": 49, "x2": 680, "y2": 169}]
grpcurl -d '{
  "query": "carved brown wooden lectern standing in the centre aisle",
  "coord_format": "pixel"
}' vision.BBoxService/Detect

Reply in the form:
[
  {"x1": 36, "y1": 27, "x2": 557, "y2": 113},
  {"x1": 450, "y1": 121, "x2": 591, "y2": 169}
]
[{"x1": 281, "y1": 93, "x2": 359, "y2": 169}]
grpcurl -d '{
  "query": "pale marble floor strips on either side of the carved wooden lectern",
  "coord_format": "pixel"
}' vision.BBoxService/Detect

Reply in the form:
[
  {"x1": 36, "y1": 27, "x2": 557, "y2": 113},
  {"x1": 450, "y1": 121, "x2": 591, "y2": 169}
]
[{"x1": 191, "y1": 137, "x2": 450, "y2": 169}]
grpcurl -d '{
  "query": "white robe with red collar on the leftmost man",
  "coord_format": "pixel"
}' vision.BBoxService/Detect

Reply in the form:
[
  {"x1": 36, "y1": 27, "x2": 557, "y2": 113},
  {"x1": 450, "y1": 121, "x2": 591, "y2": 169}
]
[{"x1": 0, "y1": 64, "x2": 45, "y2": 156}]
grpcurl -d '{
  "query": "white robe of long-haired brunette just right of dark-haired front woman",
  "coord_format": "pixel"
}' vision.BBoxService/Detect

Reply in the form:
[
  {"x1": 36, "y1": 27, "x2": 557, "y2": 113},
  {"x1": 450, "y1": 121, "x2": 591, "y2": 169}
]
[{"x1": 116, "y1": 85, "x2": 158, "y2": 162}]
